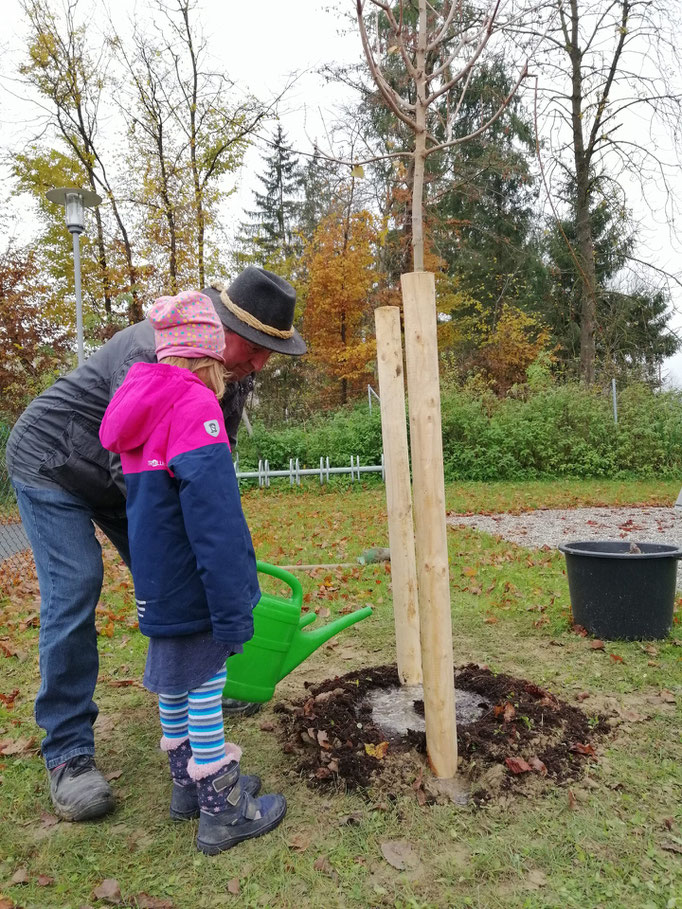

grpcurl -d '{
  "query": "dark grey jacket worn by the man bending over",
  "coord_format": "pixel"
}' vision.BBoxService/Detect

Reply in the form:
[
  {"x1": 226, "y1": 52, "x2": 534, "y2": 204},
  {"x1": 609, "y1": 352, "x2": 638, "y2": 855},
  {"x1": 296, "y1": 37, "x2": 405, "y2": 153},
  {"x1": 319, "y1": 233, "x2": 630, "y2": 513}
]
[{"x1": 6, "y1": 321, "x2": 253, "y2": 511}]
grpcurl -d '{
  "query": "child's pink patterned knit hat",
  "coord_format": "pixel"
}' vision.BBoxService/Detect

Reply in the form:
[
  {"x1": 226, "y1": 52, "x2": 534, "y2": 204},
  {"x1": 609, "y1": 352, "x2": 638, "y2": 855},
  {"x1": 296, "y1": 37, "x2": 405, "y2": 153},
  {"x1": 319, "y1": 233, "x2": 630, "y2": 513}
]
[{"x1": 147, "y1": 290, "x2": 225, "y2": 360}]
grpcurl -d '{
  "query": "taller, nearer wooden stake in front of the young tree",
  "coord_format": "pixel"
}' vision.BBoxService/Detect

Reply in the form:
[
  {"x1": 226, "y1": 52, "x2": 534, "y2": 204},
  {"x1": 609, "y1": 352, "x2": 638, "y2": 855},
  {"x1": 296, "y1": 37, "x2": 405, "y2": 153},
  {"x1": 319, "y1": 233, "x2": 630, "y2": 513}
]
[{"x1": 400, "y1": 272, "x2": 457, "y2": 778}]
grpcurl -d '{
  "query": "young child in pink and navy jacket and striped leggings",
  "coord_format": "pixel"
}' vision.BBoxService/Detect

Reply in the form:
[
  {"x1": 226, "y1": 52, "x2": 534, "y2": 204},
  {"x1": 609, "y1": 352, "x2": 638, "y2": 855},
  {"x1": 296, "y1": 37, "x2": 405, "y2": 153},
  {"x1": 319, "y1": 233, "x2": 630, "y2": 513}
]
[{"x1": 100, "y1": 291, "x2": 286, "y2": 854}]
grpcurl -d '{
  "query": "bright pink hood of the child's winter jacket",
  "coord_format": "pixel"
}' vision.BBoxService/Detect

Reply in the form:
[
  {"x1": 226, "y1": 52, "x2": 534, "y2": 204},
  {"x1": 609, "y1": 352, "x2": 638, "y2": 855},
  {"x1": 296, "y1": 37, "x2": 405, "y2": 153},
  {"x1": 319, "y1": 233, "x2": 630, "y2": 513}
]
[{"x1": 99, "y1": 363, "x2": 206, "y2": 454}]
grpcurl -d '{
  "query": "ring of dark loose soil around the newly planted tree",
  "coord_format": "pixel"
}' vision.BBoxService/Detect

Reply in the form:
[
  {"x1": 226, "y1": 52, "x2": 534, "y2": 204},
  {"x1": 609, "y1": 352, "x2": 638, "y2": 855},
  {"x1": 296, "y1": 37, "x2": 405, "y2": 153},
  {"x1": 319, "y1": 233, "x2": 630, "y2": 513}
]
[{"x1": 275, "y1": 663, "x2": 609, "y2": 802}]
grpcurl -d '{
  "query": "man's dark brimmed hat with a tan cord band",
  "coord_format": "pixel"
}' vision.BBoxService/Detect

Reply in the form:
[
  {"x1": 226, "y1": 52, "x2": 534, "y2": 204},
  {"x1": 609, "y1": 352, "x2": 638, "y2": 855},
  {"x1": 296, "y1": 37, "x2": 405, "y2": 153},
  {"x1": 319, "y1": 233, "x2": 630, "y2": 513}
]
[{"x1": 201, "y1": 265, "x2": 307, "y2": 356}]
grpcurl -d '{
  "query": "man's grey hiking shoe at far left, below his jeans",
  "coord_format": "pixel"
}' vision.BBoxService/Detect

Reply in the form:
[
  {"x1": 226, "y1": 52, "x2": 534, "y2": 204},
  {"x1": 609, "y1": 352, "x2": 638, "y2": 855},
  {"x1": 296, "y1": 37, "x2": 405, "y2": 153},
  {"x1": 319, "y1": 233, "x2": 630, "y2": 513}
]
[{"x1": 49, "y1": 754, "x2": 114, "y2": 821}]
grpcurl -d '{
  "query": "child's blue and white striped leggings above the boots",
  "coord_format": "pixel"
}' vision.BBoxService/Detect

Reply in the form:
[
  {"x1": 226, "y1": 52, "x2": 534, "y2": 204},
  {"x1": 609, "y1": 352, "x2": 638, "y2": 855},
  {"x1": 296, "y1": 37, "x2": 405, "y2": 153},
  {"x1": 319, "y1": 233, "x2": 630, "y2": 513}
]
[{"x1": 159, "y1": 668, "x2": 227, "y2": 764}]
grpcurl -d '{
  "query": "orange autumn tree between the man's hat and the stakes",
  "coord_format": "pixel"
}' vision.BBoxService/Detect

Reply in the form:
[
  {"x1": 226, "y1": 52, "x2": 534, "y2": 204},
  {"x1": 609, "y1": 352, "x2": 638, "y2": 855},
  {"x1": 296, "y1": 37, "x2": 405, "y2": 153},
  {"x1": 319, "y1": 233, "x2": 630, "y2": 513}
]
[{"x1": 304, "y1": 211, "x2": 381, "y2": 404}]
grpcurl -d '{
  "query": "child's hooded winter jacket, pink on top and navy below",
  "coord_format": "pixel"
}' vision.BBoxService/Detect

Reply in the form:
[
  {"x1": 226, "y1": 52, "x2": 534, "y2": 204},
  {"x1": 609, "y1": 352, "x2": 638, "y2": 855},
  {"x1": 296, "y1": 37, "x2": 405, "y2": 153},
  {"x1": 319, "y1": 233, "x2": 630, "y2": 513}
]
[{"x1": 99, "y1": 363, "x2": 260, "y2": 644}]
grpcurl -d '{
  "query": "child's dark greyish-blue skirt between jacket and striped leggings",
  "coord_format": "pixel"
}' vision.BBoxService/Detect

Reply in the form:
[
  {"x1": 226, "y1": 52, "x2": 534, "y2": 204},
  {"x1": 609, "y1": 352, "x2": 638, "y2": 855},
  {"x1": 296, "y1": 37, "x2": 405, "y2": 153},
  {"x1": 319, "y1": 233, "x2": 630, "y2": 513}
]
[{"x1": 142, "y1": 631, "x2": 244, "y2": 694}]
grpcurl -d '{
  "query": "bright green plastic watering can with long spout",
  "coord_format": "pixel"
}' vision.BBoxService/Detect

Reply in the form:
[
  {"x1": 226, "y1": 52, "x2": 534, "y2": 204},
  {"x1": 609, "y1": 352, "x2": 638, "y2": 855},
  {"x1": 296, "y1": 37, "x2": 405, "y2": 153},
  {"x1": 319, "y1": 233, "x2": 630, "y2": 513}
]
[{"x1": 223, "y1": 562, "x2": 372, "y2": 704}]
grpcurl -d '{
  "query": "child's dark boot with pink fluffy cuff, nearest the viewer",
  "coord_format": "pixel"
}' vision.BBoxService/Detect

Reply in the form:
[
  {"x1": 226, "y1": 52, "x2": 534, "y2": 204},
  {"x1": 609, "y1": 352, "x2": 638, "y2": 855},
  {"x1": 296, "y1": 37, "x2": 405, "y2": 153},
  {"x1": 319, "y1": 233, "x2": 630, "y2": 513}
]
[{"x1": 187, "y1": 760, "x2": 287, "y2": 855}]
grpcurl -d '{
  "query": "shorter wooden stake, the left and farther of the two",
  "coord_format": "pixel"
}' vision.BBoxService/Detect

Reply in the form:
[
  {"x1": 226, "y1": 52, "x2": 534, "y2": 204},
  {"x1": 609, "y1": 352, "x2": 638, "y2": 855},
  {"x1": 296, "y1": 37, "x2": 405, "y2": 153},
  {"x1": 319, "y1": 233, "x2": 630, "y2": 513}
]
[{"x1": 374, "y1": 306, "x2": 422, "y2": 685}]
